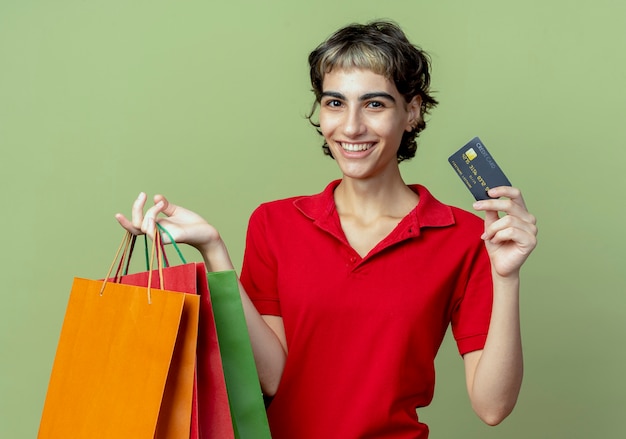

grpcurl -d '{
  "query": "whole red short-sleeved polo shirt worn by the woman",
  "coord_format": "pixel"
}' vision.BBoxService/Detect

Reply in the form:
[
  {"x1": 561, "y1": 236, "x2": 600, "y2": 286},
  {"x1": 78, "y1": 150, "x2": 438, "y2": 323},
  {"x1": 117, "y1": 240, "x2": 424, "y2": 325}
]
[{"x1": 241, "y1": 181, "x2": 492, "y2": 439}]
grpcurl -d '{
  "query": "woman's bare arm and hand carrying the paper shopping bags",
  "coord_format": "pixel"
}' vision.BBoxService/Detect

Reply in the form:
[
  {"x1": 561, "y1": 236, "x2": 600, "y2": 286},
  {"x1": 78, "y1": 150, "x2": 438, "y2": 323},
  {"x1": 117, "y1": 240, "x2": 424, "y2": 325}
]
[{"x1": 115, "y1": 193, "x2": 287, "y2": 396}]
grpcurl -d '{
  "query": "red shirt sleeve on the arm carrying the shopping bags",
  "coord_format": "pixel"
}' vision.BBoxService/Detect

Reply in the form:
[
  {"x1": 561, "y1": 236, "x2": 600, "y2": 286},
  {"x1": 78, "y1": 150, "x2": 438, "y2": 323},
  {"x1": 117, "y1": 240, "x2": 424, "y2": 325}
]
[{"x1": 240, "y1": 205, "x2": 282, "y2": 316}]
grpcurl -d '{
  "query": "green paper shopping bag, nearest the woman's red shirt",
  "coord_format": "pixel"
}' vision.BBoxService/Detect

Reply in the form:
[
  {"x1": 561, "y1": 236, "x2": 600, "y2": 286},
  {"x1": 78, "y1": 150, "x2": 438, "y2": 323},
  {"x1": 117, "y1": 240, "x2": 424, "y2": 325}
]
[{"x1": 207, "y1": 271, "x2": 271, "y2": 439}]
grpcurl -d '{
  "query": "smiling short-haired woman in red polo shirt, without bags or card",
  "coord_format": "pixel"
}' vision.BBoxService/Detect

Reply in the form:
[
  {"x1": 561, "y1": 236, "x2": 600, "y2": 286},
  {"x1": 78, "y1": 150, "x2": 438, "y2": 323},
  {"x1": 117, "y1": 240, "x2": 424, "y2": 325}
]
[{"x1": 117, "y1": 22, "x2": 537, "y2": 439}]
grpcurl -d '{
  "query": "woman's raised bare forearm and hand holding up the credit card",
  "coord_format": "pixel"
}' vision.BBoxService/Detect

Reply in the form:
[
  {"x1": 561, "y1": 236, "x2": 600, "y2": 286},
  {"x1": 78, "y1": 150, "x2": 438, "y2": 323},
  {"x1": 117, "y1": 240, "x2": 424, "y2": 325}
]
[{"x1": 463, "y1": 187, "x2": 537, "y2": 425}]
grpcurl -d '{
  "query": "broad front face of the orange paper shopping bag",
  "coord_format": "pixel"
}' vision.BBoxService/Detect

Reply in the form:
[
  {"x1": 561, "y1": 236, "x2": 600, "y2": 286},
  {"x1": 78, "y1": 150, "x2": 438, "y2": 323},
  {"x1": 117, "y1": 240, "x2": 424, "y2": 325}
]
[{"x1": 38, "y1": 278, "x2": 194, "y2": 439}]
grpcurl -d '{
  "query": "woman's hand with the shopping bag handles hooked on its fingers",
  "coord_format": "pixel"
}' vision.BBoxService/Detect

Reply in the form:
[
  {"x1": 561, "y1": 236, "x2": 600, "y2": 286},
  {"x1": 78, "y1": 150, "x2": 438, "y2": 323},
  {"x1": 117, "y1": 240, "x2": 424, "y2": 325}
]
[{"x1": 115, "y1": 192, "x2": 223, "y2": 254}]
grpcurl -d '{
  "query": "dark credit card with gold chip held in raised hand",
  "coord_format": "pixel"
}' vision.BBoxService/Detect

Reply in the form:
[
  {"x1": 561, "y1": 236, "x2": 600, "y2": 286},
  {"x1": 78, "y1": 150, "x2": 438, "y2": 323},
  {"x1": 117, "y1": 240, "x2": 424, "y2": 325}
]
[{"x1": 448, "y1": 137, "x2": 511, "y2": 200}]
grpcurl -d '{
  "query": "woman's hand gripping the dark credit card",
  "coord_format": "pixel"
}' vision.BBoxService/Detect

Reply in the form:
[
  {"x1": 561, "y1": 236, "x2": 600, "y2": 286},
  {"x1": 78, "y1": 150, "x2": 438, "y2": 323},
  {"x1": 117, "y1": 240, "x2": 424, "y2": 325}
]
[{"x1": 474, "y1": 186, "x2": 537, "y2": 277}]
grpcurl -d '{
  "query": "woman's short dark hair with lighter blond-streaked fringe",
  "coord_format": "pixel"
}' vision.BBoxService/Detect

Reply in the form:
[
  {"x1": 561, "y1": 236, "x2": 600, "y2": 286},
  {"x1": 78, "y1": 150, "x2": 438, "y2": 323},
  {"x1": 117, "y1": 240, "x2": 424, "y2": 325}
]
[{"x1": 307, "y1": 21, "x2": 437, "y2": 162}]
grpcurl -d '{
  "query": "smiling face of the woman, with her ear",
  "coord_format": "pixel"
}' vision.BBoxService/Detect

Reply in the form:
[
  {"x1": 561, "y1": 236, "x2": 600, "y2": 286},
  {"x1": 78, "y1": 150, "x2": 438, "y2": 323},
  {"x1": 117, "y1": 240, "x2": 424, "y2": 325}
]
[{"x1": 320, "y1": 69, "x2": 420, "y2": 179}]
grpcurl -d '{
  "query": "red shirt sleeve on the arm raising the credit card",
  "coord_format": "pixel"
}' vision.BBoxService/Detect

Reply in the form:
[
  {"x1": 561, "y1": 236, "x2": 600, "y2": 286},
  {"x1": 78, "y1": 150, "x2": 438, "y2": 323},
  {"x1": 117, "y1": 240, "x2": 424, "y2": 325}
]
[{"x1": 452, "y1": 241, "x2": 493, "y2": 355}]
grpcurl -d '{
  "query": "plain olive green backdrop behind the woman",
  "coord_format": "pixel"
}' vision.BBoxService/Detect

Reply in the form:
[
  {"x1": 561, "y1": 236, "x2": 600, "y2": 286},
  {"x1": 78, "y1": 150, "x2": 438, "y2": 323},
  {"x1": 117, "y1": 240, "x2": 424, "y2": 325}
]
[{"x1": 0, "y1": 0, "x2": 626, "y2": 439}]
